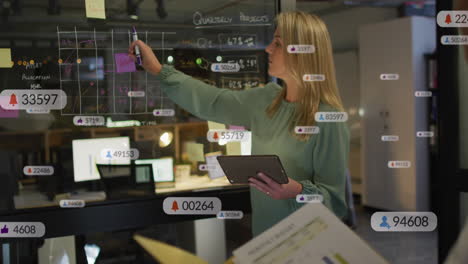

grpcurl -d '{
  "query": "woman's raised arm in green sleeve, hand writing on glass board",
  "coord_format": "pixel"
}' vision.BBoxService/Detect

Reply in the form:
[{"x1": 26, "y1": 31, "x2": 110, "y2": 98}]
[{"x1": 129, "y1": 40, "x2": 267, "y2": 127}]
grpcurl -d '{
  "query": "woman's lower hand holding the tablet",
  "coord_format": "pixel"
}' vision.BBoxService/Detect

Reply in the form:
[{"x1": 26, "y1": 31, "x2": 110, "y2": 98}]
[{"x1": 249, "y1": 172, "x2": 302, "y2": 200}]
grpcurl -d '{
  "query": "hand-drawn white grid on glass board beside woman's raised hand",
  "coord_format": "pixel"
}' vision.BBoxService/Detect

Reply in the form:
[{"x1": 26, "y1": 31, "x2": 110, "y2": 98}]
[{"x1": 57, "y1": 27, "x2": 176, "y2": 115}]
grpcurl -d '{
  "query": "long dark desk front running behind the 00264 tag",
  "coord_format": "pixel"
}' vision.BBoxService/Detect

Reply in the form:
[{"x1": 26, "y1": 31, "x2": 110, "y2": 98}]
[{"x1": 0, "y1": 181, "x2": 251, "y2": 241}]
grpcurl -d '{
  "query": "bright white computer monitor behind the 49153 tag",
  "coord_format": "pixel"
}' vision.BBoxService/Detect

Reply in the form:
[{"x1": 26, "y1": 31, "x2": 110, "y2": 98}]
[{"x1": 72, "y1": 137, "x2": 130, "y2": 182}]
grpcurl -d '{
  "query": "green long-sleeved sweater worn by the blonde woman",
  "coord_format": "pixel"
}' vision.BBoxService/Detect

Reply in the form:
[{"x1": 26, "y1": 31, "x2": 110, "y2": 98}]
[{"x1": 157, "y1": 65, "x2": 349, "y2": 236}]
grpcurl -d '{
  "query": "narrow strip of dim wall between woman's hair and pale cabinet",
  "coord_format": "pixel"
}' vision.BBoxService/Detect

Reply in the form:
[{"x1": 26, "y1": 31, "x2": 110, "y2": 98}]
[{"x1": 319, "y1": 7, "x2": 397, "y2": 193}]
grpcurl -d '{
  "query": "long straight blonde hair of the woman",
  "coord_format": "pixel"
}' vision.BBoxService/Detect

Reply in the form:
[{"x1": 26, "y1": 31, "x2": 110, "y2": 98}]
[{"x1": 266, "y1": 11, "x2": 343, "y2": 141}]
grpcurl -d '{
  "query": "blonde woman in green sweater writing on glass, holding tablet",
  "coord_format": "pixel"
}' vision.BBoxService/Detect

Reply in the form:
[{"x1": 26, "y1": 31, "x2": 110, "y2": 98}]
[{"x1": 129, "y1": 12, "x2": 349, "y2": 236}]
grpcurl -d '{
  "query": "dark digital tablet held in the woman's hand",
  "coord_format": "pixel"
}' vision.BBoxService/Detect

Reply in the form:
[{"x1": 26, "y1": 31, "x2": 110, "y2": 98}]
[{"x1": 217, "y1": 155, "x2": 288, "y2": 184}]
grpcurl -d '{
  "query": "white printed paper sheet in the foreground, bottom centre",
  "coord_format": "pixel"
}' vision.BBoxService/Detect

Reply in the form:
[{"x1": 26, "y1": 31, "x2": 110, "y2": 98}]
[{"x1": 233, "y1": 203, "x2": 388, "y2": 264}]
